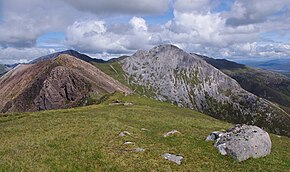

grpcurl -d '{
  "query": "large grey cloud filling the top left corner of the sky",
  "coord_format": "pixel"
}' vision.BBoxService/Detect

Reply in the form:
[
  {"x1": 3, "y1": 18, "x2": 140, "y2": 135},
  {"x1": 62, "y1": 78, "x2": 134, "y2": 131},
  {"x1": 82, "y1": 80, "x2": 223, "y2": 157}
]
[{"x1": 0, "y1": 0, "x2": 78, "y2": 48}]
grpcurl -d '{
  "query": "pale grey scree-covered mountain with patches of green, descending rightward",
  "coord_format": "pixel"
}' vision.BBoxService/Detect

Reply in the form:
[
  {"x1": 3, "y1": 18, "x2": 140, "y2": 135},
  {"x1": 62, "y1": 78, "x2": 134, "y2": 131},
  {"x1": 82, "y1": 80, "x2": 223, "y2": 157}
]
[{"x1": 121, "y1": 45, "x2": 290, "y2": 136}]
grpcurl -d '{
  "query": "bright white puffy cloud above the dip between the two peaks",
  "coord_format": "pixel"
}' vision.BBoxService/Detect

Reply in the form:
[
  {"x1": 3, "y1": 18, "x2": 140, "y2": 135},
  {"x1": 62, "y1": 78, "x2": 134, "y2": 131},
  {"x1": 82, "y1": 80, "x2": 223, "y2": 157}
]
[{"x1": 66, "y1": 17, "x2": 150, "y2": 53}]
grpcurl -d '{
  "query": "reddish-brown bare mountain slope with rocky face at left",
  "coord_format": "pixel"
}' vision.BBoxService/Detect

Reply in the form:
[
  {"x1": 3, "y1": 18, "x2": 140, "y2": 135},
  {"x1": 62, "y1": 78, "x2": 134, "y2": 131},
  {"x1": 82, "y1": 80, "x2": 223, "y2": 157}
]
[{"x1": 0, "y1": 54, "x2": 130, "y2": 112}]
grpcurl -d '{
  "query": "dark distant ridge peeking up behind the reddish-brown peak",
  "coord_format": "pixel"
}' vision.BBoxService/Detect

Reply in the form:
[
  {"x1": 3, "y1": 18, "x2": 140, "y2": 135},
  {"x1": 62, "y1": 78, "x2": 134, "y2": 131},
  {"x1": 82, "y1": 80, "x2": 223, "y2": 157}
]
[{"x1": 30, "y1": 50, "x2": 105, "y2": 64}]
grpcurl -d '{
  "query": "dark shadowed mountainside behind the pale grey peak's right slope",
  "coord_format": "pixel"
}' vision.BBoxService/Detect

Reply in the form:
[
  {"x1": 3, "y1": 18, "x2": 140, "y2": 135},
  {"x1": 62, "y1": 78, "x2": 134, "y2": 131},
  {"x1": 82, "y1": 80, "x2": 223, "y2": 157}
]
[{"x1": 200, "y1": 56, "x2": 290, "y2": 112}]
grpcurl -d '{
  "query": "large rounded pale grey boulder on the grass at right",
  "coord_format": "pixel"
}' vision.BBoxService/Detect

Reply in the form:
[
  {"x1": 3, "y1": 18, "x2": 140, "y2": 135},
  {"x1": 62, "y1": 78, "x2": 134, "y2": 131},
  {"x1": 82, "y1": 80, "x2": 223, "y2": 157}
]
[{"x1": 206, "y1": 125, "x2": 272, "y2": 161}]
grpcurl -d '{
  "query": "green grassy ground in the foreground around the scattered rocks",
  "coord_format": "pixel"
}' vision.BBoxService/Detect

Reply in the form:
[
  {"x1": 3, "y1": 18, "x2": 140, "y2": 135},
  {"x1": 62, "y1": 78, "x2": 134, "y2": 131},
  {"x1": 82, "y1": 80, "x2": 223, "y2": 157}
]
[{"x1": 0, "y1": 94, "x2": 290, "y2": 172}]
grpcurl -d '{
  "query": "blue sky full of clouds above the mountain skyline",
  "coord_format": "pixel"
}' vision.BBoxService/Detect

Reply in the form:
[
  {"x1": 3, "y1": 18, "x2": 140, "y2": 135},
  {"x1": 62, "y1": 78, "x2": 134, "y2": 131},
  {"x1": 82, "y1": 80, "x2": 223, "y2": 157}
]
[{"x1": 0, "y1": 0, "x2": 290, "y2": 64}]
